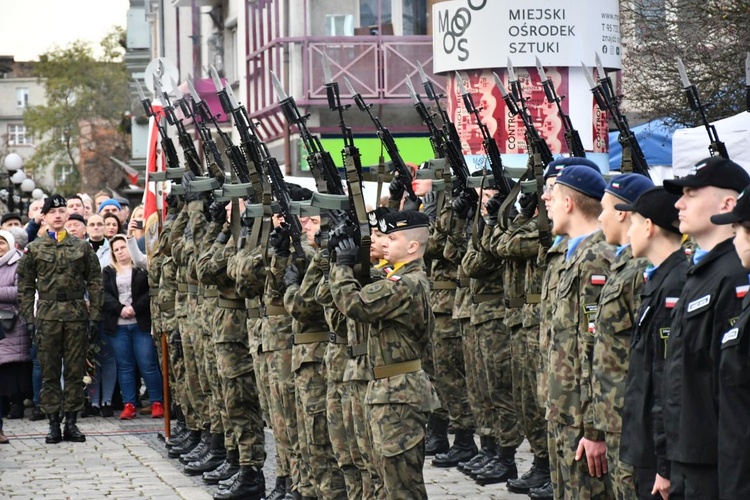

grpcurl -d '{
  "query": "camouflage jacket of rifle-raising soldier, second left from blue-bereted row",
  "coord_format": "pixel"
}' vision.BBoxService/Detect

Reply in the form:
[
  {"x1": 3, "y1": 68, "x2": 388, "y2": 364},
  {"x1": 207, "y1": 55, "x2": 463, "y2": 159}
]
[{"x1": 461, "y1": 222, "x2": 505, "y2": 325}]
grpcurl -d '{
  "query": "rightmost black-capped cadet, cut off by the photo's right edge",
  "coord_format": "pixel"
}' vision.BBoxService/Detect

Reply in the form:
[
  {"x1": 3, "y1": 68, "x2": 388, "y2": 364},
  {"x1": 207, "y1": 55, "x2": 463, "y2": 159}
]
[{"x1": 711, "y1": 187, "x2": 750, "y2": 500}]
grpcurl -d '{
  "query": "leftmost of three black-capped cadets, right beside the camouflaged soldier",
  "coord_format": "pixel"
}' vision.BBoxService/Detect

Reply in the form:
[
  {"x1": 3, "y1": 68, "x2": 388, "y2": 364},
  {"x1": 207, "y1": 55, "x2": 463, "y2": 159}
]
[{"x1": 615, "y1": 187, "x2": 688, "y2": 499}]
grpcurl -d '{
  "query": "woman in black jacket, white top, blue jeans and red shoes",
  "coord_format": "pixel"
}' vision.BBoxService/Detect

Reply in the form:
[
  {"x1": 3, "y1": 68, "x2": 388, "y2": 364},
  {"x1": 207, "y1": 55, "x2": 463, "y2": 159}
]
[{"x1": 102, "y1": 235, "x2": 164, "y2": 420}]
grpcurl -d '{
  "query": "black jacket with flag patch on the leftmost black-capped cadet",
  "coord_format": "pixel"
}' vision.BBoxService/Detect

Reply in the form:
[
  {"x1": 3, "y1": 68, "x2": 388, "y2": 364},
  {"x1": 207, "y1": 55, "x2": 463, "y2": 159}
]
[{"x1": 620, "y1": 248, "x2": 690, "y2": 478}]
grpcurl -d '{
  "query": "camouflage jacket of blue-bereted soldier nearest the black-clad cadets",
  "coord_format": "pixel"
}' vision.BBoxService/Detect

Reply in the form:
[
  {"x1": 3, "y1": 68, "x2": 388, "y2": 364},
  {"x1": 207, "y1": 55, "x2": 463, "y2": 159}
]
[{"x1": 586, "y1": 246, "x2": 648, "y2": 439}]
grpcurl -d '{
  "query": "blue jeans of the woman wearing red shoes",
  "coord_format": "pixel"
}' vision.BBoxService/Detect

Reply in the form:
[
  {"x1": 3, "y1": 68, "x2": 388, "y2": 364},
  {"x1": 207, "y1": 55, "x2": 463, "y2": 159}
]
[{"x1": 109, "y1": 323, "x2": 163, "y2": 404}]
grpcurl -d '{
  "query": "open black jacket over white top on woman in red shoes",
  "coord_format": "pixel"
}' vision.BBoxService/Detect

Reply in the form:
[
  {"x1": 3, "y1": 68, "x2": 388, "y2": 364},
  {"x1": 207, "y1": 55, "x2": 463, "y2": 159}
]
[{"x1": 102, "y1": 266, "x2": 151, "y2": 335}]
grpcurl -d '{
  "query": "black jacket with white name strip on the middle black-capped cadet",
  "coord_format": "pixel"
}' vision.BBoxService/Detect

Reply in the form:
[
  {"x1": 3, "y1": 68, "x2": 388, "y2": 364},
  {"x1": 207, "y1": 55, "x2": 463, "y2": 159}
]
[{"x1": 662, "y1": 238, "x2": 747, "y2": 465}]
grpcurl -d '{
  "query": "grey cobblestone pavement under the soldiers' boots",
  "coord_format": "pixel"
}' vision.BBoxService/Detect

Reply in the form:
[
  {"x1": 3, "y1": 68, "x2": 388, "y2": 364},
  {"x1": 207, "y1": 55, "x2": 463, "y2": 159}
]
[{"x1": 0, "y1": 410, "x2": 532, "y2": 500}]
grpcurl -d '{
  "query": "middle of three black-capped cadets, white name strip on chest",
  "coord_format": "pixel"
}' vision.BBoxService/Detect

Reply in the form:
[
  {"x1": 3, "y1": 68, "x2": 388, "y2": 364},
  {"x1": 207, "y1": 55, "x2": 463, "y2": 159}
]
[{"x1": 663, "y1": 158, "x2": 750, "y2": 499}]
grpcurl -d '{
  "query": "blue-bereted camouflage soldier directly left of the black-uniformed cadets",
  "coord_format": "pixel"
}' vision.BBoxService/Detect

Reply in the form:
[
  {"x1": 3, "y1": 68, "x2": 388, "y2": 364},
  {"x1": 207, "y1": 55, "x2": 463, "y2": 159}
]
[{"x1": 579, "y1": 174, "x2": 654, "y2": 500}]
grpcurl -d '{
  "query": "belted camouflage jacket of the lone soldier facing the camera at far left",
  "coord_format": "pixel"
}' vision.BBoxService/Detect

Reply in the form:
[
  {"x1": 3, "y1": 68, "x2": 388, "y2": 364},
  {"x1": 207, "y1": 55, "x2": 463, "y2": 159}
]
[{"x1": 17, "y1": 234, "x2": 103, "y2": 321}]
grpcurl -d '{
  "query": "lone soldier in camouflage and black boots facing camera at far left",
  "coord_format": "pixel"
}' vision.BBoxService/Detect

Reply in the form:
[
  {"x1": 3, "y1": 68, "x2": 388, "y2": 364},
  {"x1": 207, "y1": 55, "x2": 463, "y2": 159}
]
[{"x1": 17, "y1": 195, "x2": 102, "y2": 444}]
